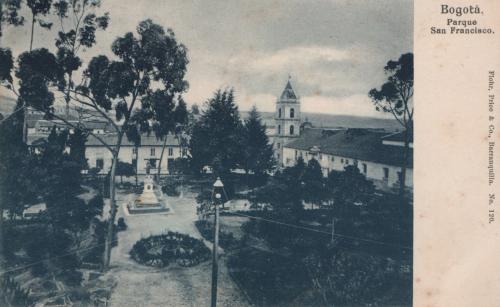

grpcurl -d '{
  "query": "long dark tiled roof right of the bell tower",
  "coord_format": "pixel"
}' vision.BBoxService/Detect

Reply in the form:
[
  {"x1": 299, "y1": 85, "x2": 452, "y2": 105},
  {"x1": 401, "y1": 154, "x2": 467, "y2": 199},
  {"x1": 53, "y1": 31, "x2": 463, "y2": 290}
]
[{"x1": 285, "y1": 129, "x2": 413, "y2": 167}]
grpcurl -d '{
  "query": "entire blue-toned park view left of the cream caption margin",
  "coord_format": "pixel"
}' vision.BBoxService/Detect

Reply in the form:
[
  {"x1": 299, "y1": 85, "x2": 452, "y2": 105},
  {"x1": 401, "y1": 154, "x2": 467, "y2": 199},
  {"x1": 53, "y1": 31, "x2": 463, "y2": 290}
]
[{"x1": 0, "y1": 0, "x2": 414, "y2": 307}]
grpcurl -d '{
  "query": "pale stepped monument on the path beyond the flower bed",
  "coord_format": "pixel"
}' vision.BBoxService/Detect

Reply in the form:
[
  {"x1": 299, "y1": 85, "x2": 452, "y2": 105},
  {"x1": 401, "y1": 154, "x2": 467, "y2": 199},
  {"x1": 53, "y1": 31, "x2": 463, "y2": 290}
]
[{"x1": 127, "y1": 175, "x2": 170, "y2": 214}]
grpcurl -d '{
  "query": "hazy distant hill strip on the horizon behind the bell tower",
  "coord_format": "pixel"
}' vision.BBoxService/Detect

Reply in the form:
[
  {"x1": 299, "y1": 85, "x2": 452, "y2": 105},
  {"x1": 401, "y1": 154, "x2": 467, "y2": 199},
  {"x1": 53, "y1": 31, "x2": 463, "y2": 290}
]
[{"x1": 241, "y1": 111, "x2": 401, "y2": 131}]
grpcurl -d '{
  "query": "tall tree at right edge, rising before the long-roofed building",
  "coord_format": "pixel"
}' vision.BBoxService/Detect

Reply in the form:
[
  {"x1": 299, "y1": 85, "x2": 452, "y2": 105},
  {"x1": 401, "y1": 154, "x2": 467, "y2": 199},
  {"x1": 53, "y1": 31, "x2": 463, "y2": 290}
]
[{"x1": 368, "y1": 53, "x2": 413, "y2": 194}]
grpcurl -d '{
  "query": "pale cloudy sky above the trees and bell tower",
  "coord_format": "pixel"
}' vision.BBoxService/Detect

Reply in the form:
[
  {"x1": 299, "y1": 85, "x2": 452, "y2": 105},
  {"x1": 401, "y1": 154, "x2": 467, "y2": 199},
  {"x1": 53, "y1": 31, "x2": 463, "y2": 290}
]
[{"x1": 0, "y1": 0, "x2": 413, "y2": 117}]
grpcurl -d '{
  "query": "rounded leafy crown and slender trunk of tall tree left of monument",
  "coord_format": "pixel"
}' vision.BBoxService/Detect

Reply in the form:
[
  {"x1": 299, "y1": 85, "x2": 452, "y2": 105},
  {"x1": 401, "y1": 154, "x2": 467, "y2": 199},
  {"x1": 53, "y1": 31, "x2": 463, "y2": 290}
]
[{"x1": 71, "y1": 20, "x2": 188, "y2": 268}]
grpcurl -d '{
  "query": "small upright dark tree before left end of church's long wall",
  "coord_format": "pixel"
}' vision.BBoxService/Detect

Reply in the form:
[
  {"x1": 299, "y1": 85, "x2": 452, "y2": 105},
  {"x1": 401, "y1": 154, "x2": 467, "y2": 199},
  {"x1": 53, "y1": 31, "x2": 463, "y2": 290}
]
[{"x1": 302, "y1": 159, "x2": 327, "y2": 209}]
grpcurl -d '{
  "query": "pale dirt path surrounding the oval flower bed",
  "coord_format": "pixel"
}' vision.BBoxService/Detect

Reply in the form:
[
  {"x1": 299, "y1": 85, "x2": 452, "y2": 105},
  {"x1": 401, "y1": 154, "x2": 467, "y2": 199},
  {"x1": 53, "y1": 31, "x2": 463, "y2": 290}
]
[{"x1": 104, "y1": 191, "x2": 249, "y2": 307}]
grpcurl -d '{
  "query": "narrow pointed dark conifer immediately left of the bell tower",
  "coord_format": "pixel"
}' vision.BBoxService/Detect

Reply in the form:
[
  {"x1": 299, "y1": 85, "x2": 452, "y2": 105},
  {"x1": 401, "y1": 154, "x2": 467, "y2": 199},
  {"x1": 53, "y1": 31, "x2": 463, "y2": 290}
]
[{"x1": 243, "y1": 106, "x2": 275, "y2": 175}]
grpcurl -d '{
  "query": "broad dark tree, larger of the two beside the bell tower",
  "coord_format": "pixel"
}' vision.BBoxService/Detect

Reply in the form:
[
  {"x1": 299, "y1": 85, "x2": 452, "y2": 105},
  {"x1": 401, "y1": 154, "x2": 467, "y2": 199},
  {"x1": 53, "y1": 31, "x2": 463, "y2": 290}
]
[{"x1": 189, "y1": 89, "x2": 243, "y2": 177}]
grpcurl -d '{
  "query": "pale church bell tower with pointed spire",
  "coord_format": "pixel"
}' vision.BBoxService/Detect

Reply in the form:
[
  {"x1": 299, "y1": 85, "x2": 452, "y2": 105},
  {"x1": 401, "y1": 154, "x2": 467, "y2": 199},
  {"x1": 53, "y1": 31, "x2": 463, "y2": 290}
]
[{"x1": 274, "y1": 77, "x2": 300, "y2": 167}]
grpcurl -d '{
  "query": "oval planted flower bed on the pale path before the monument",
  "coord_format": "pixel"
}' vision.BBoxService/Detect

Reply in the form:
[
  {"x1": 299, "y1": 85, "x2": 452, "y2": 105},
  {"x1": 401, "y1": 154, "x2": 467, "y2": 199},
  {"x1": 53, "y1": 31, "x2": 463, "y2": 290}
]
[{"x1": 130, "y1": 231, "x2": 210, "y2": 267}]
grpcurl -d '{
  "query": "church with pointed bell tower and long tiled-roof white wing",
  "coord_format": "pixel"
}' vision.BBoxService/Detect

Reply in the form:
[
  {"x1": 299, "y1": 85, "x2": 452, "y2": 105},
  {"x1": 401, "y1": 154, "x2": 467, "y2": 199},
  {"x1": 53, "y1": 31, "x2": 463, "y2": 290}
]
[{"x1": 269, "y1": 79, "x2": 413, "y2": 190}]
